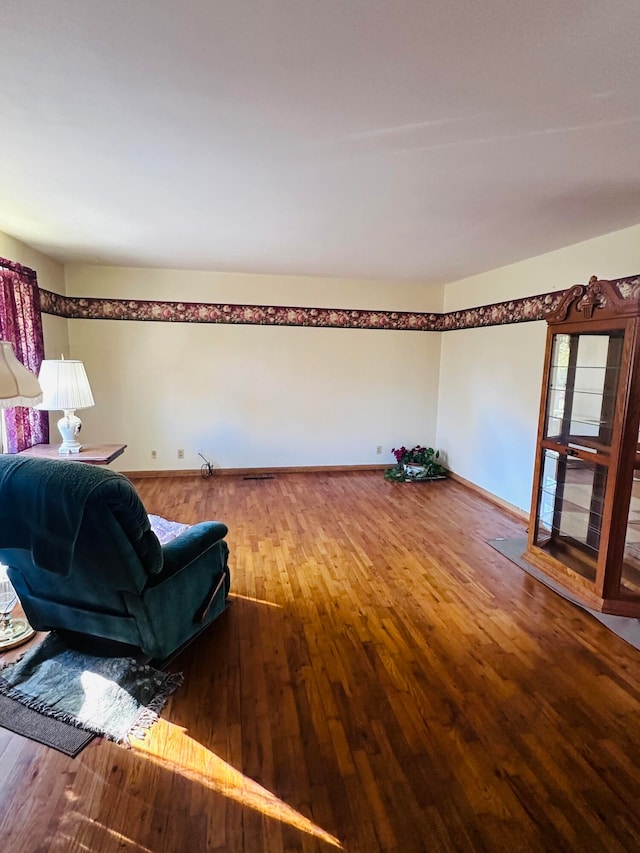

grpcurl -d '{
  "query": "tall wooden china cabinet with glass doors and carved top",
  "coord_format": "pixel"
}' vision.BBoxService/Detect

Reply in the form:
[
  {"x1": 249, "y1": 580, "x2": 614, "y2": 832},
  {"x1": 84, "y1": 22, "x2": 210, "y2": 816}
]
[{"x1": 523, "y1": 276, "x2": 640, "y2": 617}]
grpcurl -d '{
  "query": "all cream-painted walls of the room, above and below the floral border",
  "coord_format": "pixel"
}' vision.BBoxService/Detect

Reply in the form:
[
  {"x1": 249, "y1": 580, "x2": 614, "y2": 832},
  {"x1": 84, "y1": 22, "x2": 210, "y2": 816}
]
[{"x1": 0, "y1": 225, "x2": 640, "y2": 500}]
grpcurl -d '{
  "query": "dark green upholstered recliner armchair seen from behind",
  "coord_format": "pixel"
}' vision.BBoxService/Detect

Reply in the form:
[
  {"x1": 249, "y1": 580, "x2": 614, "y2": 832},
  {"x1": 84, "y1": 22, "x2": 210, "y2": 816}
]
[{"x1": 0, "y1": 455, "x2": 230, "y2": 663}]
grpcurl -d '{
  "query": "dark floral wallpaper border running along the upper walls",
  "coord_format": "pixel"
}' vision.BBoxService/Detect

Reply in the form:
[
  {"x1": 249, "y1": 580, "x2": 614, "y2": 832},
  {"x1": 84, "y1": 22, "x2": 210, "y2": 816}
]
[{"x1": 40, "y1": 276, "x2": 640, "y2": 332}]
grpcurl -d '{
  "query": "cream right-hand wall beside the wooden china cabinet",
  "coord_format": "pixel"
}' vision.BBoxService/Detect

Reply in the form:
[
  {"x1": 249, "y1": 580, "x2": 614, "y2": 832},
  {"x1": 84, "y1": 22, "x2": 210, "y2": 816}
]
[{"x1": 436, "y1": 225, "x2": 640, "y2": 511}]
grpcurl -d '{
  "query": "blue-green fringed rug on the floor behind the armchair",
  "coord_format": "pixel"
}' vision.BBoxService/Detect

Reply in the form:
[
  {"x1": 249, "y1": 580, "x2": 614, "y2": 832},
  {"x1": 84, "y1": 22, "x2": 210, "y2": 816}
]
[{"x1": 0, "y1": 633, "x2": 183, "y2": 746}]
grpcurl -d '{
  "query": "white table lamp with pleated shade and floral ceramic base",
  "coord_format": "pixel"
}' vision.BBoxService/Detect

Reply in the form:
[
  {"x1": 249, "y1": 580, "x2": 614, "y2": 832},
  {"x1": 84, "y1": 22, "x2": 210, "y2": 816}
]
[{"x1": 36, "y1": 358, "x2": 95, "y2": 454}]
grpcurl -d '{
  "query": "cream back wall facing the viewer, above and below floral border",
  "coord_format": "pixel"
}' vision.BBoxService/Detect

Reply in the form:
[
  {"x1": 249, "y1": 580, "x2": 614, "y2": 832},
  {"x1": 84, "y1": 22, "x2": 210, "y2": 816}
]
[{"x1": 66, "y1": 265, "x2": 442, "y2": 471}]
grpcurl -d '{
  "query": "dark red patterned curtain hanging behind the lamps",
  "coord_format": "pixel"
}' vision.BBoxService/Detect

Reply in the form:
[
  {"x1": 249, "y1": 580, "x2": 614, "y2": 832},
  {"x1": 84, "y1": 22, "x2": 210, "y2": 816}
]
[{"x1": 0, "y1": 258, "x2": 49, "y2": 453}]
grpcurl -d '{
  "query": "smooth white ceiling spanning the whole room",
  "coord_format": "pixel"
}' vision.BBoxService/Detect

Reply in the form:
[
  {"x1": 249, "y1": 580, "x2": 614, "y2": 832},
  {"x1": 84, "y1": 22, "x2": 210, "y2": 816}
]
[{"x1": 0, "y1": 0, "x2": 640, "y2": 283}]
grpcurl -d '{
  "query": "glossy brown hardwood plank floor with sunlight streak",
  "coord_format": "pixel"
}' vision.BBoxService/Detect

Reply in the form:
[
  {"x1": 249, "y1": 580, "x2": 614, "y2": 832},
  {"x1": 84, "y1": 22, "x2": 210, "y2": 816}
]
[{"x1": 0, "y1": 472, "x2": 640, "y2": 853}]
